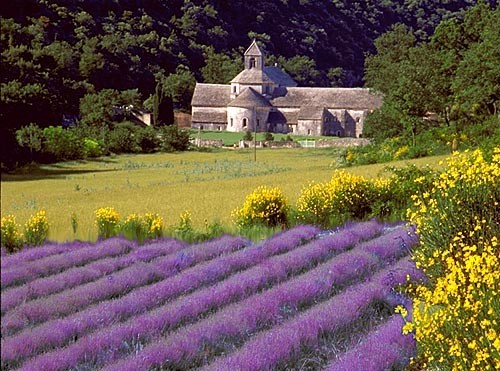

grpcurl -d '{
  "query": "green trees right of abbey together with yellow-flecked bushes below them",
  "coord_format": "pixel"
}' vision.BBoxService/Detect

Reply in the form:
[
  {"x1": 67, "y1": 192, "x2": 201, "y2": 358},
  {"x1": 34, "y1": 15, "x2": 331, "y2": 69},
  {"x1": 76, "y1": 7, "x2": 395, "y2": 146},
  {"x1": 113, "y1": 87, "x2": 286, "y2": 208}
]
[{"x1": 360, "y1": 2, "x2": 500, "y2": 164}]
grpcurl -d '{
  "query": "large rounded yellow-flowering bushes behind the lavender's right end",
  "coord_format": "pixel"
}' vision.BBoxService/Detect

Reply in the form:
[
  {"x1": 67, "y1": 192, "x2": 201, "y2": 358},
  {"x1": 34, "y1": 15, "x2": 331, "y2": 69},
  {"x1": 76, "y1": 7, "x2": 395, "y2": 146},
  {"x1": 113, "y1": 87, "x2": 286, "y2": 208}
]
[{"x1": 233, "y1": 165, "x2": 436, "y2": 228}]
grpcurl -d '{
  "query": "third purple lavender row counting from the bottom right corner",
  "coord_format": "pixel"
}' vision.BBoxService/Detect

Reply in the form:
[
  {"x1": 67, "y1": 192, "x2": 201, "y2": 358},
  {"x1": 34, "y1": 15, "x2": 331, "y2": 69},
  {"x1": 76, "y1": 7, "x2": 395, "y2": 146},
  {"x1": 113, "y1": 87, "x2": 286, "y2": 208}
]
[{"x1": 101, "y1": 230, "x2": 418, "y2": 369}]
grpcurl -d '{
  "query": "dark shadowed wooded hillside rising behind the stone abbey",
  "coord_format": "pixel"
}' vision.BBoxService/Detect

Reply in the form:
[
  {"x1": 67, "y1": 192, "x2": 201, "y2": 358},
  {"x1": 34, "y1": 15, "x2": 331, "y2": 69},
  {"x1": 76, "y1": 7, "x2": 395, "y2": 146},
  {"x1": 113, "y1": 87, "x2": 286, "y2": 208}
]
[{"x1": 0, "y1": 0, "x2": 488, "y2": 166}]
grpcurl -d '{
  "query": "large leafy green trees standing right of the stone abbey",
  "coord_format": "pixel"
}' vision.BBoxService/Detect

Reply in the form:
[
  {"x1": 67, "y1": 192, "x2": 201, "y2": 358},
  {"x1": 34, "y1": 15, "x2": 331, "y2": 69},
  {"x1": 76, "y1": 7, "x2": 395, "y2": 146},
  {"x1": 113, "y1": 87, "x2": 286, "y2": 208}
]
[{"x1": 364, "y1": 2, "x2": 500, "y2": 145}]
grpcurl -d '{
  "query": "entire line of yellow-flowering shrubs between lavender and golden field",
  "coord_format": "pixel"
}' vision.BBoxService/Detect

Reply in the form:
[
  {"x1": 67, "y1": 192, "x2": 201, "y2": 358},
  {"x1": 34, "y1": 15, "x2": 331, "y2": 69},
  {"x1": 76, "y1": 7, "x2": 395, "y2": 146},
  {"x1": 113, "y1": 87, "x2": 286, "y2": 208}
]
[{"x1": 2, "y1": 165, "x2": 436, "y2": 252}]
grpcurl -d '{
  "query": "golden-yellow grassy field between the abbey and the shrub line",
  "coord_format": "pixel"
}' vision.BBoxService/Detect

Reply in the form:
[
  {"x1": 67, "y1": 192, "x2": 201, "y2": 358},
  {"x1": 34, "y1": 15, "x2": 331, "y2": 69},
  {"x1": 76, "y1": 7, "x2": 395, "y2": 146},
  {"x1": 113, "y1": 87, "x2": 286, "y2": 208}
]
[{"x1": 1, "y1": 149, "x2": 443, "y2": 241}]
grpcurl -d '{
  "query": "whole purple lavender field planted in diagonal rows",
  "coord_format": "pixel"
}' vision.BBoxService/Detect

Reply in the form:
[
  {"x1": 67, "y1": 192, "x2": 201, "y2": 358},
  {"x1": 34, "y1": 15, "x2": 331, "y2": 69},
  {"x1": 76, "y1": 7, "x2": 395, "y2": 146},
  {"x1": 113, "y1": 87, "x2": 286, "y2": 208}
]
[{"x1": 1, "y1": 221, "x2": 422, "y2": 371}]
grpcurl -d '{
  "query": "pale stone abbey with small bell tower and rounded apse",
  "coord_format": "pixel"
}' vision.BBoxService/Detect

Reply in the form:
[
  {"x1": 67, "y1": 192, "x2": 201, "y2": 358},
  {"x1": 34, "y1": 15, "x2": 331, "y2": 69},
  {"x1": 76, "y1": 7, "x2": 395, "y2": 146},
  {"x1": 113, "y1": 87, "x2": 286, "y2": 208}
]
[{"x1": 191, "y1": 41, "x2": 382, "y2": 137}]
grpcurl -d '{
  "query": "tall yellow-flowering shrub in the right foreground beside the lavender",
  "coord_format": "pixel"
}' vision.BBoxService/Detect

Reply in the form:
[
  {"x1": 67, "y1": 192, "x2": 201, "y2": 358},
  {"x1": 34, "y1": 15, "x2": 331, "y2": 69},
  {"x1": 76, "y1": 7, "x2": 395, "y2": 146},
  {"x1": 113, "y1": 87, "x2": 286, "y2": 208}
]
[{"x1": 403, "y1": 148, "x2": 500, "y2": 370}]
